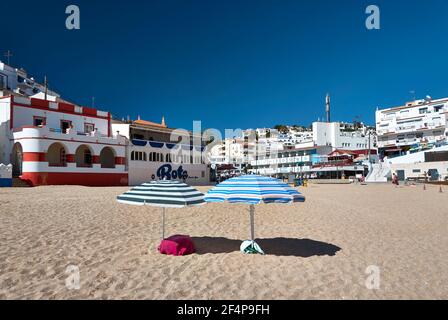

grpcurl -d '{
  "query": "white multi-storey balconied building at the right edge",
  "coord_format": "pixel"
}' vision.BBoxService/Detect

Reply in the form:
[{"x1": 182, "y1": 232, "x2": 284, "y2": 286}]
[{"x1": 367, "y1": 96, "x2": 448, "y2": 182}]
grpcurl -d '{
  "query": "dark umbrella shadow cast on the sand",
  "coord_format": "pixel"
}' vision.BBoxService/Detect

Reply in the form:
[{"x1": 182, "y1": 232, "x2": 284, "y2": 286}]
[{"x1": 192, "y1": 237, "x2": 342, "y2": 258}]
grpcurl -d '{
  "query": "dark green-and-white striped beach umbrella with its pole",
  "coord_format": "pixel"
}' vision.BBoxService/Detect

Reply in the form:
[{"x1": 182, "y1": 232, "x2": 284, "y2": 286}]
[{"x1": 117, "y1": 180, "x2": 205, "y2": 239}]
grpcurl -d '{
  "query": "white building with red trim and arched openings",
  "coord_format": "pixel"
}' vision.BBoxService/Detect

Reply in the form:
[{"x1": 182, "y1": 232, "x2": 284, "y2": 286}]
[{"x1": 0, "y1": 94, "x2": 128, "y2": 186}]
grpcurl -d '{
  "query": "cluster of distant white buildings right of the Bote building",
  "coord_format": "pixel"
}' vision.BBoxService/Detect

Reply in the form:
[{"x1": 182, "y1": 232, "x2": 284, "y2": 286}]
[{"x1": 212, "y1": 122, "x2": 377, "y2": 178}]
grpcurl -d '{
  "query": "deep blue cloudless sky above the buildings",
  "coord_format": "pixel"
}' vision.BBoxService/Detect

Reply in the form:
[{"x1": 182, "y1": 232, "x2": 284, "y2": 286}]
[{"x1": 0, "y1": 0, "x2": 448, "y2": 130}]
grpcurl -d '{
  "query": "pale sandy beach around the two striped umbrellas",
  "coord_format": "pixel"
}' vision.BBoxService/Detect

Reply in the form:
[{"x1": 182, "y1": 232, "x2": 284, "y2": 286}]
[{"x1": 0, "y1": 185, "x2": 448, "y2": 299}]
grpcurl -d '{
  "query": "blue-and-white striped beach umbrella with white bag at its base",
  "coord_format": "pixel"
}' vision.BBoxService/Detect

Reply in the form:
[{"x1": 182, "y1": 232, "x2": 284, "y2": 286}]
[{"x1": 204, "y1": 175, "x2": 305, "y2": 254}]
